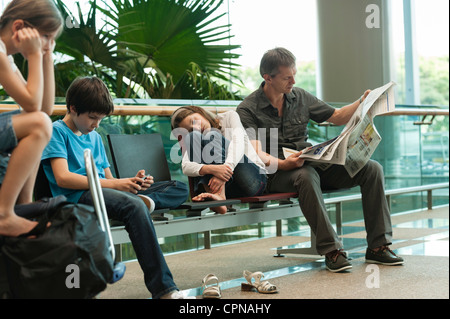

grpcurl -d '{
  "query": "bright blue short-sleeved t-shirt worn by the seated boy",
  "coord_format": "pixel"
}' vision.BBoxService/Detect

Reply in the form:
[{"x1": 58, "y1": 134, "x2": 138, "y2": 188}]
[{"x1": 42, "y1": 120, "x2": 110, "y2": 203}]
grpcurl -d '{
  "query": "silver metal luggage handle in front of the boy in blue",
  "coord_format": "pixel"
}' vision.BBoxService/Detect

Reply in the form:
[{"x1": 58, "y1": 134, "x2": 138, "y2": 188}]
[{"x1": 84, "y1": 149, "x2": 116, "y2": 260}]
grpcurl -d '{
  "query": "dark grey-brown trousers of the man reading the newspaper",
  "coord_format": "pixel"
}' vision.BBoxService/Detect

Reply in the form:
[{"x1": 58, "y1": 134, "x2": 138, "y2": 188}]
[{"x1": 268, "y1": 160, "x2": 392, "y2": 255}]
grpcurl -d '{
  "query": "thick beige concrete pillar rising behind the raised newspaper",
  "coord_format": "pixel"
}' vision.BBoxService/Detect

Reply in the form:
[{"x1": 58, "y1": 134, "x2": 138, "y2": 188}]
[{"x1": 317, "y1": 0, "x2": 392, "y2": 102}]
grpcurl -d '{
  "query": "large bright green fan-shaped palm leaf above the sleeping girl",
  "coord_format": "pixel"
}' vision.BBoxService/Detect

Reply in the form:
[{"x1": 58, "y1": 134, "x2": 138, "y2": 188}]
[{"x1": 105, "y1": 0, "x2": 240, "y2": 82}]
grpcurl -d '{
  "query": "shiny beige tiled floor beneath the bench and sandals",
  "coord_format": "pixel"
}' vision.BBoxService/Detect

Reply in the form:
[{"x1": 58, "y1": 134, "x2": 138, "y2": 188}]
[{"x1": 100, "y1": 206, "x2": 449, "y2": 299}]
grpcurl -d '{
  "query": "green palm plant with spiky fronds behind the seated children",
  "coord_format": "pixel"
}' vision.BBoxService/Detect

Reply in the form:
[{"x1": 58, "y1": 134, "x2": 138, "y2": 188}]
[{"x1": 52, "y1": 0, "x2": 243, "y2": 99}]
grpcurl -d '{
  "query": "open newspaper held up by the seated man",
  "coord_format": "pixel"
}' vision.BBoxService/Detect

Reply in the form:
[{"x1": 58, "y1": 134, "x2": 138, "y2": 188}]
[{"x1": 283, "y1": 82, "x2": 395, "y2": 177}]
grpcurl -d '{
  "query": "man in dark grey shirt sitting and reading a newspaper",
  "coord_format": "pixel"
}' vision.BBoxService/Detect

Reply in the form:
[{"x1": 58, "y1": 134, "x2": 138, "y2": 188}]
[{"x1": 237, "y1": 48, "x2": 403, "y2": 272}]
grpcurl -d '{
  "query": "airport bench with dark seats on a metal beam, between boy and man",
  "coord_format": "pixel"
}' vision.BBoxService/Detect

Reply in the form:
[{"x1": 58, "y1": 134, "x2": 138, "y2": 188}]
[{"x1": 107, "y1": 133, "x2": 344, "y2": 260}]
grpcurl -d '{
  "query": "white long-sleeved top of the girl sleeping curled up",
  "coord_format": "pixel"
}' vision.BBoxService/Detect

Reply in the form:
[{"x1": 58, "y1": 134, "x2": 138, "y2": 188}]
[{"x1": 181, "y1": 111, "x2": 267, "y2": 177}]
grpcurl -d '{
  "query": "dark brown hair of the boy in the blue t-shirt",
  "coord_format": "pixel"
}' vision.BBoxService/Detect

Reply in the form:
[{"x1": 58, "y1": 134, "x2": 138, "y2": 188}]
[{"x1": 66, "y1": 76, "x2": 114, "y2": 115}]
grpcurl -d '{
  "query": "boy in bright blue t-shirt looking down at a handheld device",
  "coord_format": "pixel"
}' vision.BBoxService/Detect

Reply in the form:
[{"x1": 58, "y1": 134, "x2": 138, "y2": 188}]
[{"x1": 42, "y1": 77, "x2": 189, "y2": 299}]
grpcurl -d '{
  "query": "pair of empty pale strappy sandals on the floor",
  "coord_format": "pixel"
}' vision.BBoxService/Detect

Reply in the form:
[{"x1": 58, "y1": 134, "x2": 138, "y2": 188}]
[{"x1": 202, "y1": 270, "x2": 278, "y2": 299}]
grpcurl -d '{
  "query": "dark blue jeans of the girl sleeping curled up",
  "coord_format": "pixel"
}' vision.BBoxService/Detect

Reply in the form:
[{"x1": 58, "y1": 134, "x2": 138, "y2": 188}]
[{"x1": 186, "y1": 130, "x2": 267, "y2": 198}]
